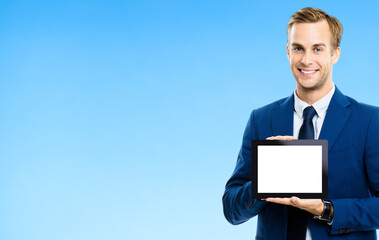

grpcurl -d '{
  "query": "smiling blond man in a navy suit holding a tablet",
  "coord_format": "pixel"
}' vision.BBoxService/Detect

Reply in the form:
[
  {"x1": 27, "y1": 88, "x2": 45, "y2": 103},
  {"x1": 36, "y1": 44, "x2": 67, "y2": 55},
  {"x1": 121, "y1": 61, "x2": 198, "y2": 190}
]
[{"x1": 223, "y1": 8, "x2": 379, "y2": 240}]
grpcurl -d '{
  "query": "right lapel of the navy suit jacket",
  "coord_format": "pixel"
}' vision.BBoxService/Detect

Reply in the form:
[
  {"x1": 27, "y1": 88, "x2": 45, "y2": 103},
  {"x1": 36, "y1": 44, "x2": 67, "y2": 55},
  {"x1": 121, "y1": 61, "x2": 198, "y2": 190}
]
[{"x1": 319, "y1": 87, "x2": 351, "y2": 151}]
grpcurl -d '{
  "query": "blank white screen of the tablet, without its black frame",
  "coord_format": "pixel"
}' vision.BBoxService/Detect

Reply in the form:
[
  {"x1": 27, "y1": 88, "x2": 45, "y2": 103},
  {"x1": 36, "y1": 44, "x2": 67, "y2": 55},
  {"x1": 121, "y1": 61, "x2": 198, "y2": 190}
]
[{"x1": 257, "y1": 145, "x2": 322, "y2": 193}]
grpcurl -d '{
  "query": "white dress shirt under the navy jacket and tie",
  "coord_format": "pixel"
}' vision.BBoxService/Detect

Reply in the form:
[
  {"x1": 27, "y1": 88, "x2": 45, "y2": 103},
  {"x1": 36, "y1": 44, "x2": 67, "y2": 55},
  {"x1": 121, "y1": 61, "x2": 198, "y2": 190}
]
[{"x1": 293, "y1": 84, "x2": 336, "y2": 240}]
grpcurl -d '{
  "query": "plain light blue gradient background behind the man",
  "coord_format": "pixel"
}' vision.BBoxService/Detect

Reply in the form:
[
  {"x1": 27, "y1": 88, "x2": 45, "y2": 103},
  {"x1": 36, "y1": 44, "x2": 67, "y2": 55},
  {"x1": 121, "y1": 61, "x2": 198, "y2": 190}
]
[{"x1": 0, "y1": 0, "x2": 379, "y2": 240}]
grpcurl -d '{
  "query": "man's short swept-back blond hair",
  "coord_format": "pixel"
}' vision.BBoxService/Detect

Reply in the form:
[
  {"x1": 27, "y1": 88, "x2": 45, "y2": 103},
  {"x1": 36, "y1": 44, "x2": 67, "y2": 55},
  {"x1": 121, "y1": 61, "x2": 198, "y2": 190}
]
[{"x1": 287, "y1": 7, "x2": 343, "y2": 51}]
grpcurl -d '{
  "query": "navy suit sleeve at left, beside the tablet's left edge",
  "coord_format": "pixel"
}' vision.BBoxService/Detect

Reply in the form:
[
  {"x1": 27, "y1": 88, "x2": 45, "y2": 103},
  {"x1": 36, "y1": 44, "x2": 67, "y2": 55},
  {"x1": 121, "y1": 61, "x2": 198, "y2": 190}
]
[{"x1": 222, "y1": 111, "x2": 267, "y2": 225}]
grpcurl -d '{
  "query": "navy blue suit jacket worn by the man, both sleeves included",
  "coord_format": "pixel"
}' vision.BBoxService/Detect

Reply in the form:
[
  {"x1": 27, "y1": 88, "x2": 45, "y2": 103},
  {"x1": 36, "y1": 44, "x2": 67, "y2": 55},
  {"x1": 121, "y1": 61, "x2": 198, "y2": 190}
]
[{"x1": 223, "y1": 88, "x2": 379, "y2": 240}]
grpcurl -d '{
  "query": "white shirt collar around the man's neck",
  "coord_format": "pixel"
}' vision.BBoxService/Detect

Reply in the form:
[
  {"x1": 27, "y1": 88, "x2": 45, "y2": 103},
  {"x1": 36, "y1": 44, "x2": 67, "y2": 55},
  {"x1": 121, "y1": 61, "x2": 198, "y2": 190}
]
[{"x1": 294, "y1": 83, "x2": 336, "y2": 118}]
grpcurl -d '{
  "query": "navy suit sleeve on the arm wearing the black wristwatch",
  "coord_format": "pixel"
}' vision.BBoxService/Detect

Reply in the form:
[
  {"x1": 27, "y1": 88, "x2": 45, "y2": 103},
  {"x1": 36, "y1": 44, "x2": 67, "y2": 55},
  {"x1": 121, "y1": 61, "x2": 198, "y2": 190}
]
[{"x1": 330, "y1": 109, "x2": 379, "y2": 234}]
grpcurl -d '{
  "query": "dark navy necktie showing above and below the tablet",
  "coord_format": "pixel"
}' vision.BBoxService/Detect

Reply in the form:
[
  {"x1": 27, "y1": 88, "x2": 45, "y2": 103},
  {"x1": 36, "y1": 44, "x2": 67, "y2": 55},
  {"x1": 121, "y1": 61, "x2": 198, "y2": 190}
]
[{"x1": 287, "y1": 106, "x2": 316, "y2": 240}]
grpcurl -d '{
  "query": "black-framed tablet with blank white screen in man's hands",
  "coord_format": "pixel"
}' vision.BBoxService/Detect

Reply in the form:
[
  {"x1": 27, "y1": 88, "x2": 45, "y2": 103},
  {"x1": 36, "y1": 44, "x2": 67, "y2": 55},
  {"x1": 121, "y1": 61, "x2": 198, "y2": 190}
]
[{"x1": 251, "y1": 140, "x2": 328, "y2": 199}]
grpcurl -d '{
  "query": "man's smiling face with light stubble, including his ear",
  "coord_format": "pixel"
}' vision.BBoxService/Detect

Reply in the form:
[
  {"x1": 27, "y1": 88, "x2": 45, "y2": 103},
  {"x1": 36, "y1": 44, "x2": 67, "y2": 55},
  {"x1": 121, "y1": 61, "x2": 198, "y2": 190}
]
[{"x1": 287, "y1": 21, "x2": 340, "y2": 91}]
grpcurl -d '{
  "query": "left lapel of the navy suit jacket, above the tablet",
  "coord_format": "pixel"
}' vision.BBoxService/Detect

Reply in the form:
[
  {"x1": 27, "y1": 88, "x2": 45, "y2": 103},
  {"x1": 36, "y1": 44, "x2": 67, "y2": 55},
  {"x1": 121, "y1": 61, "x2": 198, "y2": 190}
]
[{"x1": 271, "y1": 94, "x2": 294, "y2": 136}]
